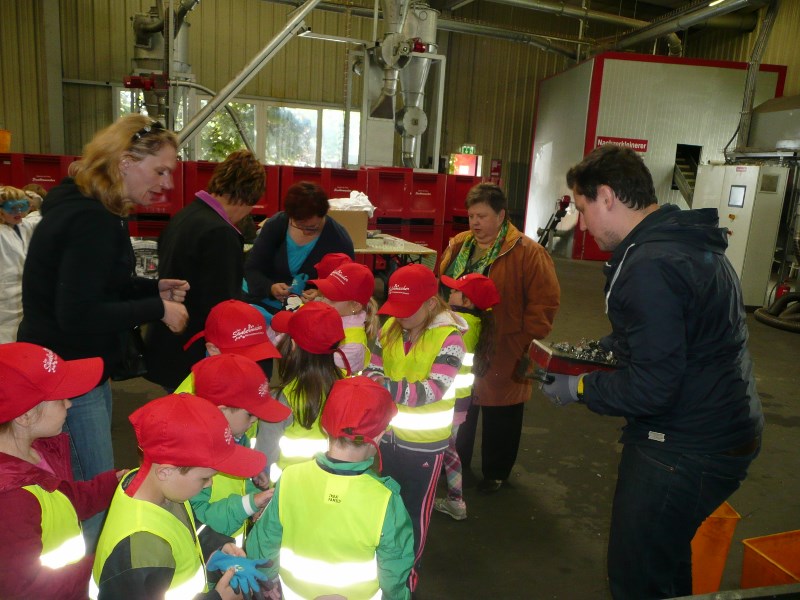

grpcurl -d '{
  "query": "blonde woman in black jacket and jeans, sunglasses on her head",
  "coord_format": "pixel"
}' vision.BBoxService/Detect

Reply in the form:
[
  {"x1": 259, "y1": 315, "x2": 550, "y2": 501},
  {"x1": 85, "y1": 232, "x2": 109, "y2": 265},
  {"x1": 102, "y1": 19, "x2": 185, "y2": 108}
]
[{"x1": 17, "y1": 115, "x2": 188, "y2": 548}]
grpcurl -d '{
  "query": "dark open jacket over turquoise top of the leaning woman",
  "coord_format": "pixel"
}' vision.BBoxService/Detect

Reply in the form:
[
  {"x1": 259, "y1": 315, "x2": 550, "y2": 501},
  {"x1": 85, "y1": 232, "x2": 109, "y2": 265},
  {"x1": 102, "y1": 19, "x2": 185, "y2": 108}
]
[{"x1": 244, "y1": 212, "x2": 355, "y2": 301}]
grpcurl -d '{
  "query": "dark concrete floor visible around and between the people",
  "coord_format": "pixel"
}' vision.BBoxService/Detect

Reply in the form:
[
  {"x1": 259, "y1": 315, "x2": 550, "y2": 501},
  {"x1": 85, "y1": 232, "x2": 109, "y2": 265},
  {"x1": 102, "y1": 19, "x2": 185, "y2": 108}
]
[{"x1": 113, "y1": 259, "x2": 800, "y2": 600}]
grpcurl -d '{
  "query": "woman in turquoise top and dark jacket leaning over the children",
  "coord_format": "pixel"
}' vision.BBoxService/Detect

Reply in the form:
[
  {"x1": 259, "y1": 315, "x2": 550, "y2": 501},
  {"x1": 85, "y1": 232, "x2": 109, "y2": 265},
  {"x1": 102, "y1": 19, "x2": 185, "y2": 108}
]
[{"x1": 244, "y1": 181, "x2": 355, "y2": 314}]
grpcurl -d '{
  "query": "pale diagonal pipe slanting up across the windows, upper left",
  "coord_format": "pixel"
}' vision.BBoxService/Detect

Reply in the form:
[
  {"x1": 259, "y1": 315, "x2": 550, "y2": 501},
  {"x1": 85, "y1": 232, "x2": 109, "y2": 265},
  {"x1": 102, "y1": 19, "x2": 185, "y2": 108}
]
[{"x1": 178, "y1": 0, "x2": 320, "y2": 146}]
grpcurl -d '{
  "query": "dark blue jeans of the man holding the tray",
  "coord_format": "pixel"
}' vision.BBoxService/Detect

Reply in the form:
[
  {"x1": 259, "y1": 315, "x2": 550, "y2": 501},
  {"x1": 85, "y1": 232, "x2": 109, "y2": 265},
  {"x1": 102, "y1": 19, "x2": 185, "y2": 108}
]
[{"x1": 608, "y1": 444, "x2": 758, "y2": 600}]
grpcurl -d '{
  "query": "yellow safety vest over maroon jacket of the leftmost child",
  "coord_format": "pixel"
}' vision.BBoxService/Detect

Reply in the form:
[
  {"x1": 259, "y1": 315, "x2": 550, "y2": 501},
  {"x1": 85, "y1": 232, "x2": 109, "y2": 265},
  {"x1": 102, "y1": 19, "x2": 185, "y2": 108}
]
[{"x1": 22, "y1": 485, "x2": 86, "y2": 569}]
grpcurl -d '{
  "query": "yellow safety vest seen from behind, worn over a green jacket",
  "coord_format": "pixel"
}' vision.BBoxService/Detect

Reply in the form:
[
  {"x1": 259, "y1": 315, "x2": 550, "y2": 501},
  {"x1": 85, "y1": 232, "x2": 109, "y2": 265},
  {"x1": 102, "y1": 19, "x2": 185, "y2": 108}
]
[{"x1": 278, "y1": 461, "x2": 391, "y2": 600}]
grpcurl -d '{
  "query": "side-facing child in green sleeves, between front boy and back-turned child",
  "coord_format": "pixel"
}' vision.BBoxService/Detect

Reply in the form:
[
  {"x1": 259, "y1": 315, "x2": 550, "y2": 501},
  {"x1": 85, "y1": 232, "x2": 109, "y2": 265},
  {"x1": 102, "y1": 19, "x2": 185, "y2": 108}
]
[{"x1": 189, "y1": 354, "x2": 291, "y2": 547}]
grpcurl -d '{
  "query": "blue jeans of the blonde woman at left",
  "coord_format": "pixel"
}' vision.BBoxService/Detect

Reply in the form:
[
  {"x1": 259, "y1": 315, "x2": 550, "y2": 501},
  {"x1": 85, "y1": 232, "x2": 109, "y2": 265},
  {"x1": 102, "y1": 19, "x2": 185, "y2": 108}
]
[{"x1": 63, "y1": 380, "x2": 114, "y2": 552}]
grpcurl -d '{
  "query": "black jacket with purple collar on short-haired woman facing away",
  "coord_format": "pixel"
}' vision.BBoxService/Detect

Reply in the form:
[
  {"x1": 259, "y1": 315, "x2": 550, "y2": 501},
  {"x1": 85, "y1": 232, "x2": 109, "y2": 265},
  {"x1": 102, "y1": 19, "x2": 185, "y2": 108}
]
[{"x1": 145, "y1": 198, "x2": 244, "y2": 389}]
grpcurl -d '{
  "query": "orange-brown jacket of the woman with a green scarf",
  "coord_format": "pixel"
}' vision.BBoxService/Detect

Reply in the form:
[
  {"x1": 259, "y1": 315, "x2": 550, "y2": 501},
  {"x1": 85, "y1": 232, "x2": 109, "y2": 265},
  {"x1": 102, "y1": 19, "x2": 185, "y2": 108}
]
[{"x1": 439, "y1": 223, "x2": 561, "y2": 406}]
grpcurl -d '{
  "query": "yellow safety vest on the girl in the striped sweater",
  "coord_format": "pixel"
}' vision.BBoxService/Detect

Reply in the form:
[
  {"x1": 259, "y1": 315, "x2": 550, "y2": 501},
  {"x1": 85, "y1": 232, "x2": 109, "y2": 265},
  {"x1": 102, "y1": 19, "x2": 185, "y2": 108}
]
[{"x1": 381, "y1": 317, "x2": 458, "y2": 449}]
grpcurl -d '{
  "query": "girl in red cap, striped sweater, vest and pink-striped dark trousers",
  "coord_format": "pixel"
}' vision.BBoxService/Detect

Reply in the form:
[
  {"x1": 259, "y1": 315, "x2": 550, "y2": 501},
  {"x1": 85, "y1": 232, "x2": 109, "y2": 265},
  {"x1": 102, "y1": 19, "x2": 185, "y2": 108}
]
[{"x1": 364, "y1": 265, "x2": 467, "y2": 592}]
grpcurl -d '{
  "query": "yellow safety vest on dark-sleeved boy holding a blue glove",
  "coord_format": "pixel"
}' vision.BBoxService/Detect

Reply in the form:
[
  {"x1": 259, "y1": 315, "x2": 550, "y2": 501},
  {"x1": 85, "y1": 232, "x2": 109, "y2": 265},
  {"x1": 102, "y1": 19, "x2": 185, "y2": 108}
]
[{"x1": 89, "y1": 469, "x2": 206, "y2": 600}]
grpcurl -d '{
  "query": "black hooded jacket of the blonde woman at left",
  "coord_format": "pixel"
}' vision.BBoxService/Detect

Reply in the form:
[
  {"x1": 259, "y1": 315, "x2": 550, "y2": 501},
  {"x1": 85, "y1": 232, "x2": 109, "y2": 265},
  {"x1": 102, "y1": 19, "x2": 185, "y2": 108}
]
[{"x1": 17, "y1": 178, "x2": 164, "y2": 381}]
